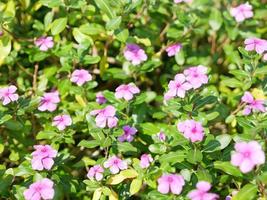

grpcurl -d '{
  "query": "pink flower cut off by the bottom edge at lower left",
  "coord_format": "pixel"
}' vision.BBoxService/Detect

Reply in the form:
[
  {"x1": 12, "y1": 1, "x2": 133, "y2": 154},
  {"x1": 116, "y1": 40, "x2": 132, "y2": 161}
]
[{"x1": 23, "y1": 178, "x2": 55, "y2": 200}]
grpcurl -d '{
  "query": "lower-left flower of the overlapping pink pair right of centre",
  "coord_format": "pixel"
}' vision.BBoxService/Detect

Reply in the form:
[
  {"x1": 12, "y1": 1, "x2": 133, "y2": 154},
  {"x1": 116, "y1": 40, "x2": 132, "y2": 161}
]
[{"x1": 165, "y1": 74, "x2": 192, "y2": 99}]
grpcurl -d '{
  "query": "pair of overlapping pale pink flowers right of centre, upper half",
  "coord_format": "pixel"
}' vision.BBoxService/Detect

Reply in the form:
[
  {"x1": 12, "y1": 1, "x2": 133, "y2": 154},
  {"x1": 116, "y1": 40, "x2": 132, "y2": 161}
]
[{"x1": 164, "y1": 65, "x2": 208, "y2": 100}]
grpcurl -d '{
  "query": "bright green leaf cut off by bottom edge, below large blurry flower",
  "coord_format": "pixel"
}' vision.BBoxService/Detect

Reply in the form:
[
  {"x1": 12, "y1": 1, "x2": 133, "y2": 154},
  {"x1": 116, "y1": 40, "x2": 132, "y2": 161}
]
[{"x1": 233, "y1": 184, "x2": 258, "y2": 200}]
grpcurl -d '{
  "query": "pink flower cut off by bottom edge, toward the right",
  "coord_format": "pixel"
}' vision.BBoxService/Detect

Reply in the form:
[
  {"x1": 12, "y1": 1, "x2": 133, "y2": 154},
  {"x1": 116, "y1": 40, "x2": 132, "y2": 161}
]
[{"x1": 187, "y1": 181, "x2": 219, "y2": 200}]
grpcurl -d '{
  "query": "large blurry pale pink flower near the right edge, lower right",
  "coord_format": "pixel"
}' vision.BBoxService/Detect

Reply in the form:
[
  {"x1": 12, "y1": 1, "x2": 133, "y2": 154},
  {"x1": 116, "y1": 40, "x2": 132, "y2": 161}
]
[{"x1": 231, "y1": 141, "x2": 265, "y2": 173}]
